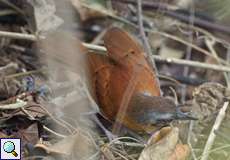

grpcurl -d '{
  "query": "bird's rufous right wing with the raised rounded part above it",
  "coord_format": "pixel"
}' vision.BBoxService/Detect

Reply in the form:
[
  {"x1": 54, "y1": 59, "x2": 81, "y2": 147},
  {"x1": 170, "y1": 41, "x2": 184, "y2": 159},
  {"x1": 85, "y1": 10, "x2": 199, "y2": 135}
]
[{"x1": 104, "y1": 28, "x2": 160, "y2": 130}]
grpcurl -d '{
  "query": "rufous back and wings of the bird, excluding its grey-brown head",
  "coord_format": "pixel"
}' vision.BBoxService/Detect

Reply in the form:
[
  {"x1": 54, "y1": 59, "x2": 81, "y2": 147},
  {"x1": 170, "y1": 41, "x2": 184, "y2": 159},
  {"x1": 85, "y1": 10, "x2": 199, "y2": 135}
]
[{"x1": 87, "y1": 28, "x2": 160, "y2": 132}]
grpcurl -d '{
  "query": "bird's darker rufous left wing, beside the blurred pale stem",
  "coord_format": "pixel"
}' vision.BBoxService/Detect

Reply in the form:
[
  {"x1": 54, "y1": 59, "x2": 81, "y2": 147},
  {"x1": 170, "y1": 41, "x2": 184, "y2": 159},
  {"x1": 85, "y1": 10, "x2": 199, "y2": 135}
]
[{"x1": 88, "y1": 53, "x2": 117, "y2": 120}]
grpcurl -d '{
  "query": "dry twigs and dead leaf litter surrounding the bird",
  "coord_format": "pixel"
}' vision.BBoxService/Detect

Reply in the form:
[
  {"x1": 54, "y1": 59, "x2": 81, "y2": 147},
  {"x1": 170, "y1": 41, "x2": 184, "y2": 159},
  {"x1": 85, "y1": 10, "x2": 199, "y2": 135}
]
[{"x1": 0, "y1": 0, "x2": 230, "y2": 160}]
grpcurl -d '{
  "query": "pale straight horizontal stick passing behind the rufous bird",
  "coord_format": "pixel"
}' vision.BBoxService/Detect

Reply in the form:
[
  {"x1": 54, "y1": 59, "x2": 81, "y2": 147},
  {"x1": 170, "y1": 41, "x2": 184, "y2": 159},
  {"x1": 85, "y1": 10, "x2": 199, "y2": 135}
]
[{"x1": 83, "y1": 43, "x2": 230, "y2": 72}]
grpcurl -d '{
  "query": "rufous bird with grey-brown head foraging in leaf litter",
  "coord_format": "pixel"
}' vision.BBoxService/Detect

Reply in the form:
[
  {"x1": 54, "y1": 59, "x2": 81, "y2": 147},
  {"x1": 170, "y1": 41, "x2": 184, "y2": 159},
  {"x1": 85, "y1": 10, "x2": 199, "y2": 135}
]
[{"x1": 89, "y1": 28, "x2": 195, "y2": 132}]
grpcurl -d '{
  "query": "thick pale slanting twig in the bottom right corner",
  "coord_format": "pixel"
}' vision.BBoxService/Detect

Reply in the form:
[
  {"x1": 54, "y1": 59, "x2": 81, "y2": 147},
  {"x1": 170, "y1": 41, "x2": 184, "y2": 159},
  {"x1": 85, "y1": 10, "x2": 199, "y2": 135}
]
[{"x1": 201, "y1": 102, "x2": 229, "y2": 160}]
